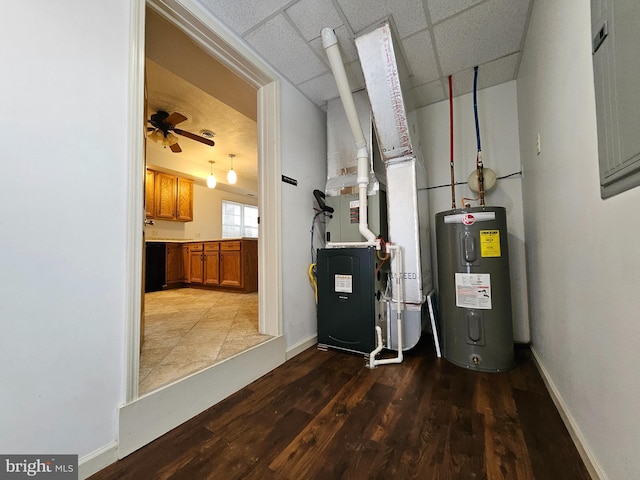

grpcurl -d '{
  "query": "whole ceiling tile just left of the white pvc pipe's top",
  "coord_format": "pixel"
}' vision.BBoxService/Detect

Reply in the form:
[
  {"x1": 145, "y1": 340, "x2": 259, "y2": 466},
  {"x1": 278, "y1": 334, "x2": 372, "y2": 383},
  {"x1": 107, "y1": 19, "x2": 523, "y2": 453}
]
[{"x1": 244, "y1": 15, "x2": 327, "y2": 84}]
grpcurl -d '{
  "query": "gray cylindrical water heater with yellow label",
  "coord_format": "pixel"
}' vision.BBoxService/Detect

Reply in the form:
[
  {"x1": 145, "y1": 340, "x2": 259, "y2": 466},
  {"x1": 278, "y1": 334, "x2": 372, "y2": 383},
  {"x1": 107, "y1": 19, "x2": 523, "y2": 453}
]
[{"x1": 436, "y1": 207, "x2": 514, "y2": 372}]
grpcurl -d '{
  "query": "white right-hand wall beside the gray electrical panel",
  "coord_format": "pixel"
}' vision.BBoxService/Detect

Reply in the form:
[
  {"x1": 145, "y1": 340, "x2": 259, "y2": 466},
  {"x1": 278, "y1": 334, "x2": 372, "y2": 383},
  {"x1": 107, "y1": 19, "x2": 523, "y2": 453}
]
[{"x1": 517, "y1": 0, "x2": 640, "y2": 480}]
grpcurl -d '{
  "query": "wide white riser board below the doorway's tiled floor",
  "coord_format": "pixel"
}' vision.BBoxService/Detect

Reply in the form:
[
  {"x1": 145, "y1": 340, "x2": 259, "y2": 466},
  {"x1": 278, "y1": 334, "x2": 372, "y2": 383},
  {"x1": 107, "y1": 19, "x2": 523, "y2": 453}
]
[{"x1": 118, "y1": 336, "x2": 286, "y2": 458}]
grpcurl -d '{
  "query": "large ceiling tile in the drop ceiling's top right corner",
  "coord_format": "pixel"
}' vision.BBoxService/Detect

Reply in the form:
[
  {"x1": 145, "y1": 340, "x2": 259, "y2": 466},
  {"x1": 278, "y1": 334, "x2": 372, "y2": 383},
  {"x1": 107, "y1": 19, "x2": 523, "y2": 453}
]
[{"x1": 434, "y1": 0, "x2": 529, "y2": 75}]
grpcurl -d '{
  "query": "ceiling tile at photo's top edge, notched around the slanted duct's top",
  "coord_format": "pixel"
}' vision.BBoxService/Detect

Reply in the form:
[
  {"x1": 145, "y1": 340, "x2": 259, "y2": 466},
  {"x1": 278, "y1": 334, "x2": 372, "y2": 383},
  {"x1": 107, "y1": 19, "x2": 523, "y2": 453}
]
[{"x1": 337, "y1": 0, "x2": 427, "y2": 38}]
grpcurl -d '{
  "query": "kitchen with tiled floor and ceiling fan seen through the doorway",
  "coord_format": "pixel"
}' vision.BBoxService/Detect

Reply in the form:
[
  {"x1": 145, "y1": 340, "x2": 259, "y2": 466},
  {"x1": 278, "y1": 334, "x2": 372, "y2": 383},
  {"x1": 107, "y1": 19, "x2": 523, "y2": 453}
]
[{"x1": 138, "y1": 7, "x2": 270, "y2": 395}]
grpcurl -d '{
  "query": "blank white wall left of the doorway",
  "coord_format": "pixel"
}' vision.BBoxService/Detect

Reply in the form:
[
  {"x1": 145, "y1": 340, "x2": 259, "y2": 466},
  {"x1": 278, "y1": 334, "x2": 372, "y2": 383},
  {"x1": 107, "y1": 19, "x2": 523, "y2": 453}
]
[{"x1": 0, "y1": 0, "x2": 131, "y2": 456}]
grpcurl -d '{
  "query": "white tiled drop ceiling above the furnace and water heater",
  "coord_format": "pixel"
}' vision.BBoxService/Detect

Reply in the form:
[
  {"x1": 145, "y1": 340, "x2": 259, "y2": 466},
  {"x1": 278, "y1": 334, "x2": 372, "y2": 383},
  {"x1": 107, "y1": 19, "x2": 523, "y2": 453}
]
[{"x1": 197, "y1": 0, "x2": 533, "y2": 108}]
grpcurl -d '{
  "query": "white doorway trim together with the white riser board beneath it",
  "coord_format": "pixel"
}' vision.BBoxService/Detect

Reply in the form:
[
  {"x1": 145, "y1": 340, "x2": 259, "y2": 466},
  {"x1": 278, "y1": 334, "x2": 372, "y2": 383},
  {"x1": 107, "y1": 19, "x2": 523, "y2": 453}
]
[{"x1": 118, "y1": 0, "x2": 286, "y2": 457}]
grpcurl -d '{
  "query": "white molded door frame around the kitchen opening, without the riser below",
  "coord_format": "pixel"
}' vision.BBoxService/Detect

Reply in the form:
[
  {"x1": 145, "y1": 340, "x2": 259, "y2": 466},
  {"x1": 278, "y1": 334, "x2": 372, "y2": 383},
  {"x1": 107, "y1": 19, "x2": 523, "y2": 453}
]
[{"x1": 121, "y1": 0, "x2": 285, "y2": 404}]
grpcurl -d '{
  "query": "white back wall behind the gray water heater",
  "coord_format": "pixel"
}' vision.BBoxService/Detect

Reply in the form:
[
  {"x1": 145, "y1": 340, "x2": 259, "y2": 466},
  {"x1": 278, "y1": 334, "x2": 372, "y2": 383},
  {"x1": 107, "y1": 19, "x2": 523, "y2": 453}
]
[{"x1": 416, "y1": 81, "x2": 530, "y2": 343}]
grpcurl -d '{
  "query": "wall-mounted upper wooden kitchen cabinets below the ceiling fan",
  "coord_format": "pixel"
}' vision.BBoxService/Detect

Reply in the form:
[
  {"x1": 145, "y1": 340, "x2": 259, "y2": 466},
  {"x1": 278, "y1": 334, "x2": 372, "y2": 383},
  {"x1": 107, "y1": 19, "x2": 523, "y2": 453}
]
[{"x1": 145, "y1": 170, "x2": 193, "y2": 222}]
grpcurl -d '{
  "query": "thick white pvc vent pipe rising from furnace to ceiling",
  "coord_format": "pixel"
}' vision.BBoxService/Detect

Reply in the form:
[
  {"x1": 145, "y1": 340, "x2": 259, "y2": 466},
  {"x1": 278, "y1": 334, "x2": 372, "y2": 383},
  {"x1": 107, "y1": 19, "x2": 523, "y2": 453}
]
[{"x1": 322, "y1": 28, "x2": 380, "y2": 249}]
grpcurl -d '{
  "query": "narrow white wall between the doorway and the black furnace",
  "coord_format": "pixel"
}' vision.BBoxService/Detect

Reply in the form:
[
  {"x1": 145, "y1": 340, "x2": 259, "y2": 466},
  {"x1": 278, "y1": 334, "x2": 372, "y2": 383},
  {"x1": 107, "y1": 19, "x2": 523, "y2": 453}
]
[{"x1": 280, "y1": 79, "x2": 327, "y2": 347}]
